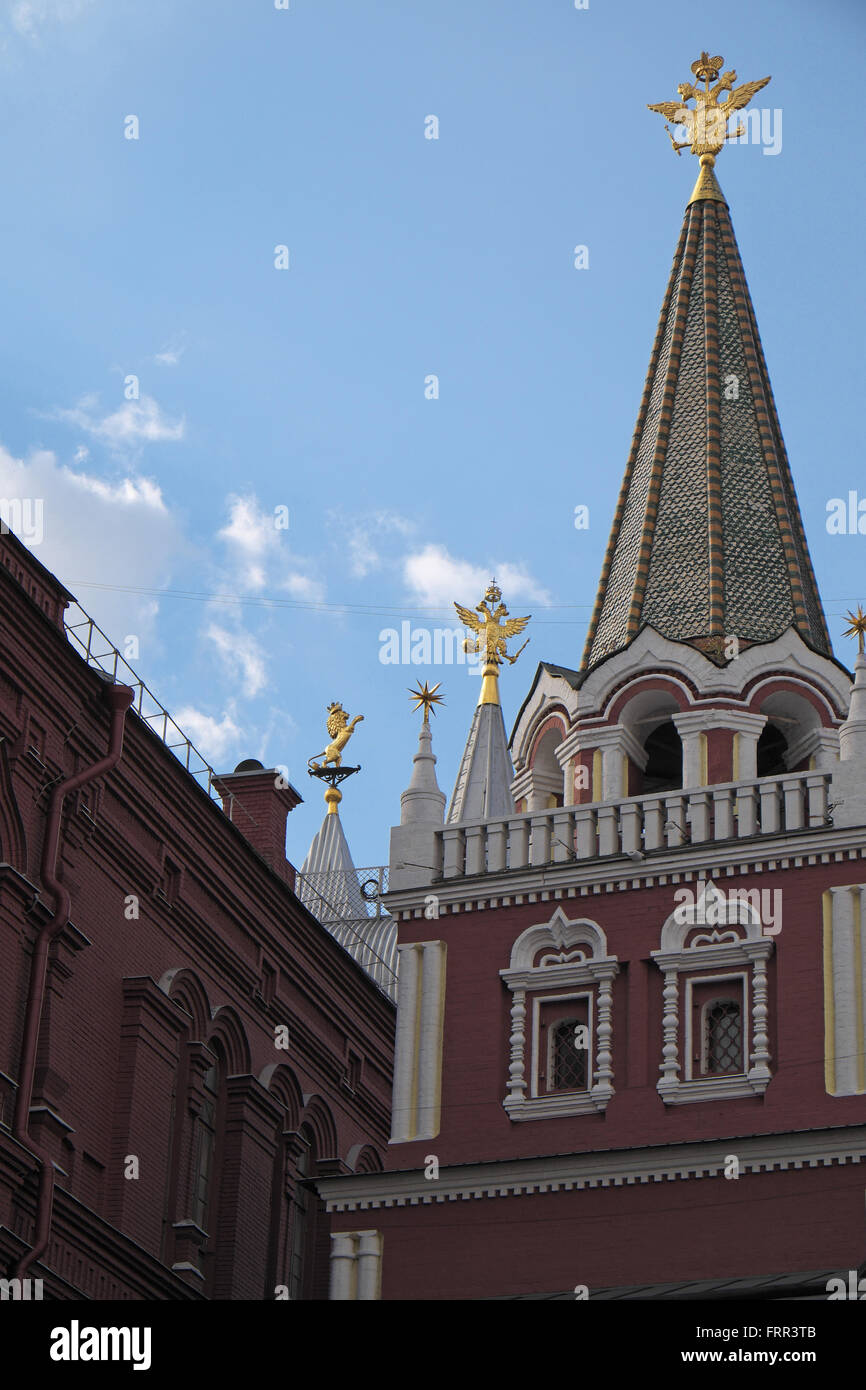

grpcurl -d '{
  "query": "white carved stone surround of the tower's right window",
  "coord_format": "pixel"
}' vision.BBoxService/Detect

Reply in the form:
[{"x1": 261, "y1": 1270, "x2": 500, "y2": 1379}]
[{"x1": 651, "y1": 878, "x2": 773, "y2": 1105}]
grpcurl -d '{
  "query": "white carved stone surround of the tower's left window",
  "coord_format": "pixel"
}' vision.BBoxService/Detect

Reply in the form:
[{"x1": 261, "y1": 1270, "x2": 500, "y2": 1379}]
[{"x1": 499, "y1": 908, "x2": 619, "y2": 1120}]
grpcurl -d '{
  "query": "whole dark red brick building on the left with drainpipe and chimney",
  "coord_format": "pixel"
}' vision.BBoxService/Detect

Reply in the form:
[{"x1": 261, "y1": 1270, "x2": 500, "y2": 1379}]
[{"x1": 0, "y1": 534, "x2": 393, "y2": 1300}]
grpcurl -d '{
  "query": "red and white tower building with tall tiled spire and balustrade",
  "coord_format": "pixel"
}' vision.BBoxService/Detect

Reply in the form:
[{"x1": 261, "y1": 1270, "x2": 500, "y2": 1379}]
[{"x1": 318, "y1": 113, "x2": 866, "y2": 1300}]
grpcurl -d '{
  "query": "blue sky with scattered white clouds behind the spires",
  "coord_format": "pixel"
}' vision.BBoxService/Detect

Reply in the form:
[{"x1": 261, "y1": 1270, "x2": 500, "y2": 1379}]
[{"x1": 0, "y1": 0, "x2": 866, "y2": 865}]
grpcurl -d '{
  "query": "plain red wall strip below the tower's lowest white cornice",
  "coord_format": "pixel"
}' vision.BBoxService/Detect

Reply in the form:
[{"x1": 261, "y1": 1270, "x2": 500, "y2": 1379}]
[{"x1": 366, "y1": 1162, "x2": 863, "y2": 1300}]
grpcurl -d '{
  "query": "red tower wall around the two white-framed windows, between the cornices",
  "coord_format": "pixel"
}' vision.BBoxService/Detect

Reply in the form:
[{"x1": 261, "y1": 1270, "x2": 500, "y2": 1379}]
[{"x1": 386, "y1": 860, "x2": 865, "y2": 1168}]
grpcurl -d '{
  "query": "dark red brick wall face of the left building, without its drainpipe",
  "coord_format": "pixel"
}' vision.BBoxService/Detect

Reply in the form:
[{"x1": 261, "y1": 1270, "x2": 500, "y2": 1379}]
[{"x1": 0, "y1": 535, "x2": 393, "y2": 1298}]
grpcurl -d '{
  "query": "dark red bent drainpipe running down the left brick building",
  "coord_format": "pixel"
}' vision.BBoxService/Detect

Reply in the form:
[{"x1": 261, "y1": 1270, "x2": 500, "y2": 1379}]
[{"x1": 13, "y1": 685, "x2": 135, "y2": 1279}]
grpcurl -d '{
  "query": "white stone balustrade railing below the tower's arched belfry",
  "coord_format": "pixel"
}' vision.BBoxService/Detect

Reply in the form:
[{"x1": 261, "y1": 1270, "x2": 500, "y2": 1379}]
[{"x1": 436, "y1": 771, "x2": 830, "y2": 878}]
